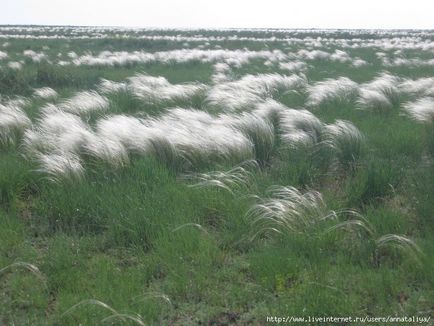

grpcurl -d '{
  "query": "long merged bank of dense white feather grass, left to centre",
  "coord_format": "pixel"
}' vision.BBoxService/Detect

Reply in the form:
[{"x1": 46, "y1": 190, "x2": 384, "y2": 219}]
[{"x1": 23, "y1": 105, "x2": 258, "y2": 179}]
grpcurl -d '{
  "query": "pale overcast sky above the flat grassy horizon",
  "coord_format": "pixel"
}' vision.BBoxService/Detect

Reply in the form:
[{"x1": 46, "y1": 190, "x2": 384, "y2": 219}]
[{"x1": 0, "y1": 0, "x2": 434, "y2": 29}]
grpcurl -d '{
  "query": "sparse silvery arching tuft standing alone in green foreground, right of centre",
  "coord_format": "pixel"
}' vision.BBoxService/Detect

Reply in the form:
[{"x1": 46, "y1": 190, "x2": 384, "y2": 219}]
[{"x1": 247, "y1": 186, "x2": 336, "y2": 238}]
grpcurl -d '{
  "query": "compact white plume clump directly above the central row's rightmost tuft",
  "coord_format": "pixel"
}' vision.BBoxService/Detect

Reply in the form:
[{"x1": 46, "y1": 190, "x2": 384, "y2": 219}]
[{"x1": 306, "y1": 77, "x2": 359, "y2": 107}]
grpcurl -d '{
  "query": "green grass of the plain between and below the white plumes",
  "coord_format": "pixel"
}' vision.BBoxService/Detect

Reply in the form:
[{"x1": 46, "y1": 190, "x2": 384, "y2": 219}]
[{"x1": 0, "y1": 27, "x2": 434, "y2": 325}]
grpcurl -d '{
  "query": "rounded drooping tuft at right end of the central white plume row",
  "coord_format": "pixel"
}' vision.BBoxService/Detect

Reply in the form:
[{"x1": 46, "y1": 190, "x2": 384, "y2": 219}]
[{"x1": 322, "y1": 120, "x2": 365, "y2": 168}]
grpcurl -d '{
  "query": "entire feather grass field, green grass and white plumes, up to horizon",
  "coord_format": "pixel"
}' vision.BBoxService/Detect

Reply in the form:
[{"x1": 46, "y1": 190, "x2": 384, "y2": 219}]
[{"x1": 0, "y1": 27, "x2": 434, "y2": 325}]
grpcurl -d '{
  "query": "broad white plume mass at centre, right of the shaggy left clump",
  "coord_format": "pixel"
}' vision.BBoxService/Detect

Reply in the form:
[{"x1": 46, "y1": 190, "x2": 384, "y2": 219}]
[{"x1": 96, "y1": 108, "x2": 253, "y2": 166}]
